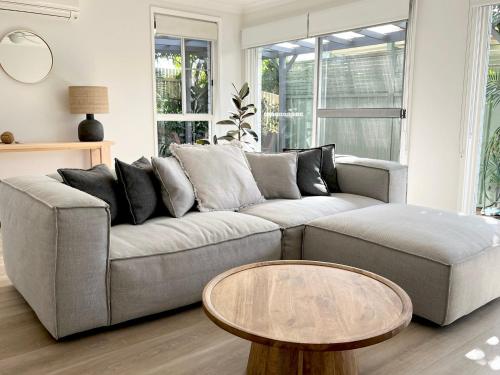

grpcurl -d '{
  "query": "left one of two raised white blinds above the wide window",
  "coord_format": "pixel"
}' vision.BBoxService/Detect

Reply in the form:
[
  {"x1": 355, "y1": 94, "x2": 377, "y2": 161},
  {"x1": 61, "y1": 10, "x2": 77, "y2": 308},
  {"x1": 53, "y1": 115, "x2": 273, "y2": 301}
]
[{"x1": 241, "y1": 14, "x2": 307, "y2": 48}]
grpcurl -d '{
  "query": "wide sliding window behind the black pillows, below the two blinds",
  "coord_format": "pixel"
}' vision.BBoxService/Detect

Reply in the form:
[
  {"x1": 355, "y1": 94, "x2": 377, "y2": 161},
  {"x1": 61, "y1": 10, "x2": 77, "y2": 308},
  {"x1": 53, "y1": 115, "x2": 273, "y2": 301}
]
[{"x1": 260, "y1": 22, "x2": 406, "y2": 160}]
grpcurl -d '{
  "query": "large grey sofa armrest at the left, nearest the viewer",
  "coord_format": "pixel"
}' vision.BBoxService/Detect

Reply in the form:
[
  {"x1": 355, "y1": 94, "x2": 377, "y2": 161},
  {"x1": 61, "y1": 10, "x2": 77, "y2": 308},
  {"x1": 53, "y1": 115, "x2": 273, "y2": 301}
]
[{"x1": 0, "y1": 176, "x2": 110, "y2": 339}]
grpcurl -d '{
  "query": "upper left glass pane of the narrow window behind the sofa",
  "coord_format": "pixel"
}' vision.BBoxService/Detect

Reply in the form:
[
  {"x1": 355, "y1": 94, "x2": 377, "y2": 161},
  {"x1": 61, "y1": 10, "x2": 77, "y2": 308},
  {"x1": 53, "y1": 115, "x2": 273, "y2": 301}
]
[{"x1": 155, "y1": 36, "x2": 182, "y2": 114}]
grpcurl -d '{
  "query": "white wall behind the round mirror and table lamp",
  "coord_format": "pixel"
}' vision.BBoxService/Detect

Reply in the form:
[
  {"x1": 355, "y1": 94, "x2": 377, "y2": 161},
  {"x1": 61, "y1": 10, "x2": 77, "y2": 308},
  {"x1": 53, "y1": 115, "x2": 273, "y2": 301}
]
[{"x1": 0, "y1": 0, "x2": 242, "y2": 178}]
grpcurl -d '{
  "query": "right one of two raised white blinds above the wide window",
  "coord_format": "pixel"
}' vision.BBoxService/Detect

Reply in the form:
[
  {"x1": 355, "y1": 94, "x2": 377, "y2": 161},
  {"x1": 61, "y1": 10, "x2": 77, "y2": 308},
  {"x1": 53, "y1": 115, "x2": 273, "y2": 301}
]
[{"x1": 308, "y1": 0, "x2": 410, "y2": 37}]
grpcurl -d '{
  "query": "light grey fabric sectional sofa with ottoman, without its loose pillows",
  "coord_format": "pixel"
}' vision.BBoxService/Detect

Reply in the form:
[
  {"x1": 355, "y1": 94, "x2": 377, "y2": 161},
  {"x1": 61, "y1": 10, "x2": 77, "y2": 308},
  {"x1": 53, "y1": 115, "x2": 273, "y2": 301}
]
[{"x1": 0, "y1": 157, "x2": 500, "y2": 339}]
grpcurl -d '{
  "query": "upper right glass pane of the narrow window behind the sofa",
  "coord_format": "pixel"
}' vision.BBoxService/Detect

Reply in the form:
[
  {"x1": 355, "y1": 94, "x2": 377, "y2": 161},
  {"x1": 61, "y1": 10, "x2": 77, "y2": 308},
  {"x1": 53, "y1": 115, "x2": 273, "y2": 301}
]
[{"x1": 185, "y1": 39, "x2": 212, "y2": 113}]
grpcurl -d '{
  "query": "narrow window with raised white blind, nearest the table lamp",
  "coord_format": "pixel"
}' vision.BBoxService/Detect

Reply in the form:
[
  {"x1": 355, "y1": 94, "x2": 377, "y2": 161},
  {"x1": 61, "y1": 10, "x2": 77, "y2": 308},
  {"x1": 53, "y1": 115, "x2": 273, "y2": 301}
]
[{"x1": 154, "y1": 12, "x2": 217, "y2": 156}]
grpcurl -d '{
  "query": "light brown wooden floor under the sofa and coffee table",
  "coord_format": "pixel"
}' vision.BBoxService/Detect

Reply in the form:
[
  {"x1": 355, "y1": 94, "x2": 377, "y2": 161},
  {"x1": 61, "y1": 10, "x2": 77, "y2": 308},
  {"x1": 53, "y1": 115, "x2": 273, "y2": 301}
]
[{"x1": 0, "y1": 236, "x2": 500, "y2": 375}]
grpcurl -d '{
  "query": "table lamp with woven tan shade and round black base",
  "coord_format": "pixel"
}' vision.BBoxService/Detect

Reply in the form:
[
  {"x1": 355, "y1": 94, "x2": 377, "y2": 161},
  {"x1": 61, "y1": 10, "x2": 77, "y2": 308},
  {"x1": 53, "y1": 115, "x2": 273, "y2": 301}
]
[{"x1": 69, "y1": 86, "x2": 109, "y2": 142}]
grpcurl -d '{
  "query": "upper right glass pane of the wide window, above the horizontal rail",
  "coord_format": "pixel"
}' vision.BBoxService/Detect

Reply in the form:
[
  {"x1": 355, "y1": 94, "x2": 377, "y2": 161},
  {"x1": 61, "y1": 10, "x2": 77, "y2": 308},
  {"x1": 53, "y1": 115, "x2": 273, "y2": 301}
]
[{"x1": 319, "y1": 22, "x2": 406, "y2": 109}]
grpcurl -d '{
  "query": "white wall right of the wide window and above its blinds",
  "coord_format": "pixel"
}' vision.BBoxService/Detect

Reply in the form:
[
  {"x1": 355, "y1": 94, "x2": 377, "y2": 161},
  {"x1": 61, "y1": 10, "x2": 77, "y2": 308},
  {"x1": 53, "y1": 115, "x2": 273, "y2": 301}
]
[{"x1": 243, "y1": 0, "x2": 469, "y2": 210}]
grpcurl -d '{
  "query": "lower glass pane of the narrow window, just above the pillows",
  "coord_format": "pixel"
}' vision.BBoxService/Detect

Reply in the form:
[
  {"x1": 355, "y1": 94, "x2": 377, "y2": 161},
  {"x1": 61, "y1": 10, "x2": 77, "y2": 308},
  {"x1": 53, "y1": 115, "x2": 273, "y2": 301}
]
[{"x1": 157, "y1": 121, "x2": 208, "y2": 156}]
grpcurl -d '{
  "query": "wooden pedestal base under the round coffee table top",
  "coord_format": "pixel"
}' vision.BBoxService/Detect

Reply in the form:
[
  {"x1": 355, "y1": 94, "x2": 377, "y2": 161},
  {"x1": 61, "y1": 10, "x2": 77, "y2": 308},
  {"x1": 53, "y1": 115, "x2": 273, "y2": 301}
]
[{"x1": 247, "y1": 343, "x2": 358, "y2": 375}]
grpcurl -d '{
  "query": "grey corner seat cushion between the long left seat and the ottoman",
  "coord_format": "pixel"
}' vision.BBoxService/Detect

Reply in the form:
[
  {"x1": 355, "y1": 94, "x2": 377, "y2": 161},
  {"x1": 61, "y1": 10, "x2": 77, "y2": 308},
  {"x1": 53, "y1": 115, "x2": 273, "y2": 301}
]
[{"x1": 241, "y1": 193, "x2": 383, "y2": 259}]
